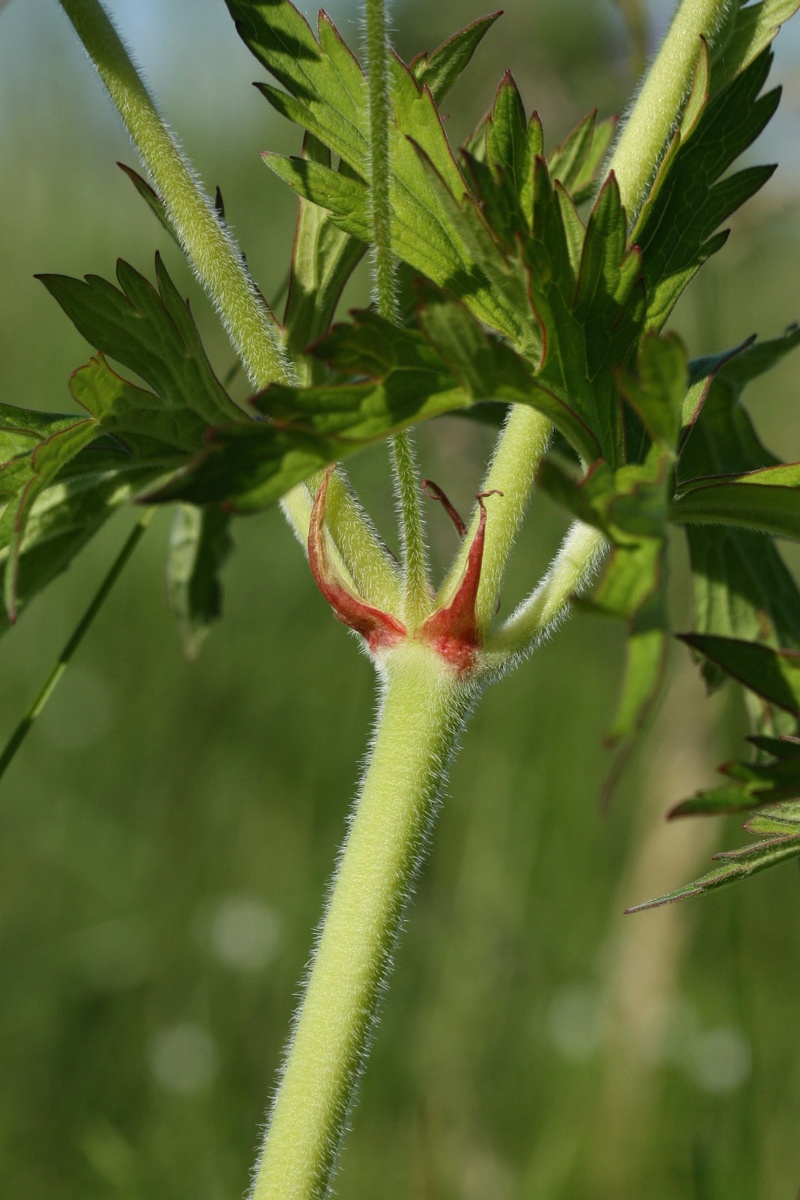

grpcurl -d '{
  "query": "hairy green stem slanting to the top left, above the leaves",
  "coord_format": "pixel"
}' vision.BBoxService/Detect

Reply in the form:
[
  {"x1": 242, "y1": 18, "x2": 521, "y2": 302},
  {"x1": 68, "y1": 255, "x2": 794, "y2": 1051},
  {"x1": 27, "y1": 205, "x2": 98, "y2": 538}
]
[{"x1": 60, "y1": 0, "x2": 293, "y2": 388}]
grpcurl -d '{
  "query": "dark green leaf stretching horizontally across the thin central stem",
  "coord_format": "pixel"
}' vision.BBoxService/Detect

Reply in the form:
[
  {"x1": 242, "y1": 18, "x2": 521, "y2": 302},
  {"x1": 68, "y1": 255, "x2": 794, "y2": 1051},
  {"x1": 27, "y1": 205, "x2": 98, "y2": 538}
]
[{"x1": 149, "y1": 296, "x2": 551, "y2": 512}]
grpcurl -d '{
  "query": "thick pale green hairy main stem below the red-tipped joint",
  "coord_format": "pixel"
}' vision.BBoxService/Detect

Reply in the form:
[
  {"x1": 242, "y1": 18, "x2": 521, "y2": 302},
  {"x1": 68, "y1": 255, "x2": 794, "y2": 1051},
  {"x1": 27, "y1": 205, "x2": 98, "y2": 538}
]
[{"x1": 252, "y1": 643, "x2": 473, "y2": 1200}]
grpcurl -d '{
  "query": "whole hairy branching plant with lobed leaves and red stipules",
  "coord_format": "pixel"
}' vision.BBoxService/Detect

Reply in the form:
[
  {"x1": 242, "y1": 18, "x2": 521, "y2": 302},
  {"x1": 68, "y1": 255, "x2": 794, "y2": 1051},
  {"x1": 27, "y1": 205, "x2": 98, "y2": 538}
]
[{"x1": 0, "y1": 0, "x2": 800, "y2": 1200}]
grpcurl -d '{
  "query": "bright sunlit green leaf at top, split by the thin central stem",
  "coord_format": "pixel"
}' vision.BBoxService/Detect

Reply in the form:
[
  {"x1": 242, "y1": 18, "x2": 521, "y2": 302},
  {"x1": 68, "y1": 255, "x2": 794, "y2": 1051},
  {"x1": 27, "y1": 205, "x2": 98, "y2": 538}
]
[{"x1": 228, "y1": 0, "x2": 521, "y2": 341}]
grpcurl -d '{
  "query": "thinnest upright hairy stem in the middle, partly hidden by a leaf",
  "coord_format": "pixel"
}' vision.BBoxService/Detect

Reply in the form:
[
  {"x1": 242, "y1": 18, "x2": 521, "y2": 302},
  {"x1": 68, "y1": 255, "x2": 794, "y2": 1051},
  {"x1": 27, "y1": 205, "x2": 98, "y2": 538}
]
[{"x1": 365, "y1": 0, "x2": 431, "y2": 626}]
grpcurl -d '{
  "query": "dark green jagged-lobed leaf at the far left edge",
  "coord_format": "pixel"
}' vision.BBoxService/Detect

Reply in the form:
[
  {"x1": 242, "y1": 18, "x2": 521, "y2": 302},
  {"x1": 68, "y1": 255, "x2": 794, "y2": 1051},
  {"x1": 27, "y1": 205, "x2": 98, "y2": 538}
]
[{"x1": 0, "y1": 259, "x2": 245, "y2": 619}]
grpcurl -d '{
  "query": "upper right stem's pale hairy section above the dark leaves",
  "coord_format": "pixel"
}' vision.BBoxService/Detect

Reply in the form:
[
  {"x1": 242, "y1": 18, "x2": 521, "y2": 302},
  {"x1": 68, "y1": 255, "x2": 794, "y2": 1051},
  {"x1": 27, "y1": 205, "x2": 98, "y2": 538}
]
[{"x1": 608, "y1": 0, "x2": 738, "y2": 223}]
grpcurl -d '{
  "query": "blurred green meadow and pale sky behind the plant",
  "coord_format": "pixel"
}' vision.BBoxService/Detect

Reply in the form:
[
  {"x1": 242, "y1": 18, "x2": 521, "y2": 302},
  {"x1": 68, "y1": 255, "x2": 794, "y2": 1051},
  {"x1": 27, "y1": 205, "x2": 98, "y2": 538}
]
[{"x1": 0, "y1": 0, "x2": 800, "y2": 1200}]
